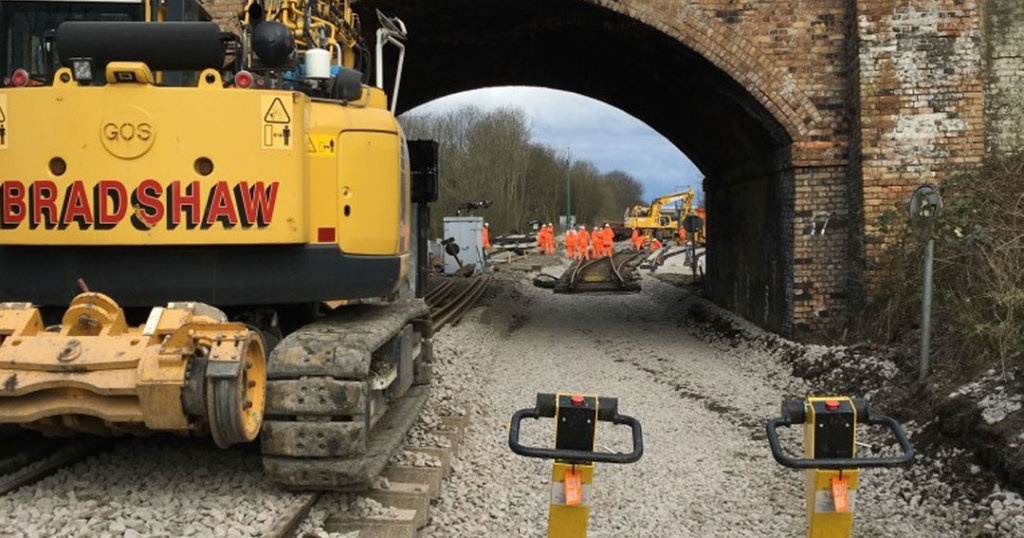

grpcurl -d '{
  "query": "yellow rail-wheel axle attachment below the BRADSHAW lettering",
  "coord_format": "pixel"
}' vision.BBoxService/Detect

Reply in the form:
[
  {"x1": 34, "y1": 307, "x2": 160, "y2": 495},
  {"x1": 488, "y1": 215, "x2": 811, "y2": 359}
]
[{"x1": 0, "y1": 293, "x2": 266, "y2": 445}]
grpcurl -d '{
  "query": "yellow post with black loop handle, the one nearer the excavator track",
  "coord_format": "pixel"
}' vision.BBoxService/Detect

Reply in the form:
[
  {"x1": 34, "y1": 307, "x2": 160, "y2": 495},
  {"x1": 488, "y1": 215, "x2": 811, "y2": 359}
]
[{"x1": 509, "y1": 394, "x2": 643, "y2": 538}]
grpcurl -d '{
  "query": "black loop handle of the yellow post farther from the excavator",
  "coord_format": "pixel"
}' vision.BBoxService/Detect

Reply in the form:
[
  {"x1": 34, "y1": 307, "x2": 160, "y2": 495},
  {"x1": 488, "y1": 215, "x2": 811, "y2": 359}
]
[{"x1": 767, "y1": 400, "x2": 913, "y2": 469}]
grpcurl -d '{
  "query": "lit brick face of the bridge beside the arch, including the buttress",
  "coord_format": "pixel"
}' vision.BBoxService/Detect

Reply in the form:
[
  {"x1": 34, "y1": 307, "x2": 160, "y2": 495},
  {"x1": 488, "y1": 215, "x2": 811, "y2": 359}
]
[{"x1": 600, "y1": 0, "x2": 995, "y2": 335}]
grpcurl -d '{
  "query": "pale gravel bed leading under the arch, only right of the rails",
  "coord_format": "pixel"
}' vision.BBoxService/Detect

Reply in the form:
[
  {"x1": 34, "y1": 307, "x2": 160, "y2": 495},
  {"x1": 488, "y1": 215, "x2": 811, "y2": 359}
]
[{"x1": 413, "y1": 267, "x2": 1024, "y2": 538}]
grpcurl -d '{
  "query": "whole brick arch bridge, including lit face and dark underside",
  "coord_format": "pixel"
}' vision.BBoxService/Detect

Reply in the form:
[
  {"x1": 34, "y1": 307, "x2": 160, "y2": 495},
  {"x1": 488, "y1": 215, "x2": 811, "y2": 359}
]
[{"x1": 288, "y1": 0, "x2": 1007, "y2": 339}]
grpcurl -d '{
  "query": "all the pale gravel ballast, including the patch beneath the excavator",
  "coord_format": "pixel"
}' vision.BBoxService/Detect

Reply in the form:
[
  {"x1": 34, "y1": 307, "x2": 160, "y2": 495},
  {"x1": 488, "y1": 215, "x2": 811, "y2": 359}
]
[{"x1": 0, "y1": 253, "x2": 1024, "y2": 538}]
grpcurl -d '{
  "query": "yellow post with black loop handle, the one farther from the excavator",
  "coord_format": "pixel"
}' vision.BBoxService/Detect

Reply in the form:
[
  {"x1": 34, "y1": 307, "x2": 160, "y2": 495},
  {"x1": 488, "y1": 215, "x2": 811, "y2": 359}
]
[{"x1": 766, "y1": 397, "x2": 913, "y2": 538}]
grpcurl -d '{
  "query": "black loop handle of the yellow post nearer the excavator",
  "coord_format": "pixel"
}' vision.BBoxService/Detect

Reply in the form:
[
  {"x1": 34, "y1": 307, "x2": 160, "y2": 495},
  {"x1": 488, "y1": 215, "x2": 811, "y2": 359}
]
[{"x1": 509, "y1": 394, "x2": 643, "y2": 463}]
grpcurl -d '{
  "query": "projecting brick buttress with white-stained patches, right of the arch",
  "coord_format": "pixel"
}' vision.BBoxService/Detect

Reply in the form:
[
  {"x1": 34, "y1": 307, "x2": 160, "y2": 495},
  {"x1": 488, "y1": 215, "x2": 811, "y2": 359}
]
[{"x1": 857, "y1": 0, "x2": 985, "y2": 293}]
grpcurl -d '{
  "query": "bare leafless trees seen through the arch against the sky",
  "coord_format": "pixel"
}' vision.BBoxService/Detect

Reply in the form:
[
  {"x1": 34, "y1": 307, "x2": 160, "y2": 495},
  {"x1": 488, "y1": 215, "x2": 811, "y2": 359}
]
[{"x1": 400, "y1": 107, "x2": 643, "y2": 233}]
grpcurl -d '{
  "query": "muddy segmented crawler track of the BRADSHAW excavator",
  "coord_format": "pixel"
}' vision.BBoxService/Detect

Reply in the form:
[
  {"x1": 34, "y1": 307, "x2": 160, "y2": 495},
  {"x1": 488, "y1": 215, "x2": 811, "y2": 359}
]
[{"x1": 261, "y1": 299, "x2": 432, "y2": 490}]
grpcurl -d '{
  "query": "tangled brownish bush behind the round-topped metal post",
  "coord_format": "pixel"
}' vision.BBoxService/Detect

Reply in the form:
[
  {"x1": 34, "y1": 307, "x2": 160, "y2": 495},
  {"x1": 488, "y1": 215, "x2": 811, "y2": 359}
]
[{"x1": 864, "y1": 156, "x2": 1024, "y2": 377}]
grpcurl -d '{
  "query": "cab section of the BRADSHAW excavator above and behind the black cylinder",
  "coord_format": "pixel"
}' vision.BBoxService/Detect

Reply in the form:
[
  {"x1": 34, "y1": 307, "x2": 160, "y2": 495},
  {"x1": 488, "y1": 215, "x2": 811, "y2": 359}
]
[{"x1": 0, "y1": 0, "x2": 143, "y2": 81}]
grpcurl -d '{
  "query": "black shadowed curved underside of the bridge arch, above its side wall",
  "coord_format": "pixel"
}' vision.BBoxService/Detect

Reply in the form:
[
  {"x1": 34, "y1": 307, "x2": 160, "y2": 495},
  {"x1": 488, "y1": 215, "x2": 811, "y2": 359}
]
[{"x1": 354, "y1": 0, "x2": 790, "y2": 177}]
